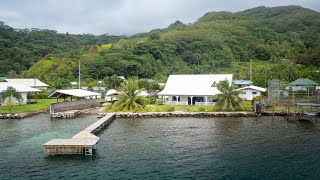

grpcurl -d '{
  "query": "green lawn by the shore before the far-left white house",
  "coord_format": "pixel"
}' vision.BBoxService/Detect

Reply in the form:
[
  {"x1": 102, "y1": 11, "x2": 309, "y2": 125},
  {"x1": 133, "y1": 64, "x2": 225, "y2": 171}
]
[{"x1": 0, "y1": 99, "x2": 57, "y2": 113}]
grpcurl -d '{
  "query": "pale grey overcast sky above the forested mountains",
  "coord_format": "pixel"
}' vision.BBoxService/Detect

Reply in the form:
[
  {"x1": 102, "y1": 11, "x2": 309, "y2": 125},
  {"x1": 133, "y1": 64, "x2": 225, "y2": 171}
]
[{"x1": 0, "y1": 0, "x2": 320, "y2": 35}]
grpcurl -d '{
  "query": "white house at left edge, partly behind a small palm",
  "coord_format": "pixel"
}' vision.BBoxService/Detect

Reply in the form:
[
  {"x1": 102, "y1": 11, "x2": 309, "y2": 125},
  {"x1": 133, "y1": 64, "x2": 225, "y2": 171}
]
[{"x1": 0, "y1": 82, "x2": 40, "y2": 106}]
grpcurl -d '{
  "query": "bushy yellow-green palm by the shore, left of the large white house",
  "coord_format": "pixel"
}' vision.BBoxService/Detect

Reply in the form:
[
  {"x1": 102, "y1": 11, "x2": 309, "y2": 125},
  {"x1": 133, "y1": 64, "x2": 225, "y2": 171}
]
[{"x1": 113, "y1": 79, "x2": 145, "y2": 111}]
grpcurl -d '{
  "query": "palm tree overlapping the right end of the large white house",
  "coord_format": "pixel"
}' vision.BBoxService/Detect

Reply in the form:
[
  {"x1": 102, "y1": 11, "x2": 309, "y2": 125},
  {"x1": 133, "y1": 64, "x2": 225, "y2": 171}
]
[{"x1": 215, "y1": 80, "x2": 242, "y2": 111}]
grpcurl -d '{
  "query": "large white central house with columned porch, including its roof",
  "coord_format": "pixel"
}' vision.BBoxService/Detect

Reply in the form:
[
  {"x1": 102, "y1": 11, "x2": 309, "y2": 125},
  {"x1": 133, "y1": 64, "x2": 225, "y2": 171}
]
[{"x1": 158, "y1": 74, "x2": 232, "y2": 105}]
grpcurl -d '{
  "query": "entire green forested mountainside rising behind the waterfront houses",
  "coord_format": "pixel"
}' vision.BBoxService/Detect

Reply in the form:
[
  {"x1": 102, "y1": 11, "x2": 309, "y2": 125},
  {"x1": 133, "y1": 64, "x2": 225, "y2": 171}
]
[{"x1": 0, "y1": 6, "x2": 320, "y2": 86}]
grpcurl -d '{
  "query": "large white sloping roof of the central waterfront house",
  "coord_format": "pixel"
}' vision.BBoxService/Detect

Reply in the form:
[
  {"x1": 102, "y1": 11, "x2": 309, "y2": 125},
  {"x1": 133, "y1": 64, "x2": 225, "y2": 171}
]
[{"x1": 158, "y1": 74, "x2": 232, "y2": 96}]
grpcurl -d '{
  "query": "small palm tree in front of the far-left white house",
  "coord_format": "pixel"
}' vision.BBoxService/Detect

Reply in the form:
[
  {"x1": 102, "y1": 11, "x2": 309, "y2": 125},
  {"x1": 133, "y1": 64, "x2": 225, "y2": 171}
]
[{"x1": 0, "y1": 87, "x2": 23, "y2": 111}]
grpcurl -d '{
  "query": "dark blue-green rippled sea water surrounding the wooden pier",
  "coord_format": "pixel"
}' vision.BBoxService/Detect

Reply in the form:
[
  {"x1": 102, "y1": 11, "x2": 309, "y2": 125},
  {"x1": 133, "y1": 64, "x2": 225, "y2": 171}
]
[{"x1": 0, "y1": 114, "x2": 320, "y2": 179}]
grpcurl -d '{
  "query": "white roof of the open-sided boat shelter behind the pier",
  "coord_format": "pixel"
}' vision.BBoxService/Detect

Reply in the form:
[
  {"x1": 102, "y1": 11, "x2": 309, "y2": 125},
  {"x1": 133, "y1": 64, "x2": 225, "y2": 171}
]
[{"x1": 49, "y1": 89, "x2": 101, "y2": 98}]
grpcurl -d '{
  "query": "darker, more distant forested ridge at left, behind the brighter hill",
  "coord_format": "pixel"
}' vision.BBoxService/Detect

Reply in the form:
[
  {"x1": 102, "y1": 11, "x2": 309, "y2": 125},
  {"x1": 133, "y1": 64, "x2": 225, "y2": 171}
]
[{"x1": 0, "y1": 21, "x2": 124, "y2": 76}]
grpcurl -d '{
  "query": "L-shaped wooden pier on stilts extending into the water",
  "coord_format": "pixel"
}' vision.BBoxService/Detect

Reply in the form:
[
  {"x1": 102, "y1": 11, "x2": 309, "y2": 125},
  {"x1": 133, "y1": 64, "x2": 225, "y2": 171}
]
[{"x1": 43, "y1": 113, "x2": 115, "y2": 156}]
